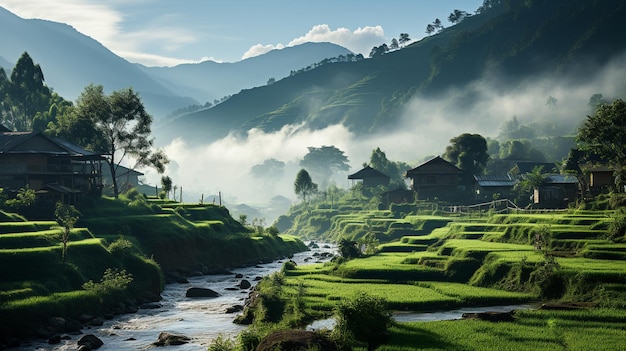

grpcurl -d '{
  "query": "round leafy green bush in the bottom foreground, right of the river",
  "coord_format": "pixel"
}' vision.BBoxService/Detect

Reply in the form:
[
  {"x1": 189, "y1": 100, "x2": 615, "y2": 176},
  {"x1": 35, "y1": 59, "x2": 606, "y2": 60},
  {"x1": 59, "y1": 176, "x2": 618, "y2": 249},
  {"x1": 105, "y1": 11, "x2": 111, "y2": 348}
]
[{"x1": 335, "y1": 292, "x2": 393, "y2": 350}]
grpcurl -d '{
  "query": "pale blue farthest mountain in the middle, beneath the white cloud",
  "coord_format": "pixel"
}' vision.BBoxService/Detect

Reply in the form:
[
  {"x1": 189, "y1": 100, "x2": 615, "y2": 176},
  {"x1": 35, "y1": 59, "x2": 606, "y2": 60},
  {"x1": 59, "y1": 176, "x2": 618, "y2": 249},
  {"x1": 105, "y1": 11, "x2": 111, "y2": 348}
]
[{"x1": 139, "y1": 43, "x2": 352, "y2": 102}]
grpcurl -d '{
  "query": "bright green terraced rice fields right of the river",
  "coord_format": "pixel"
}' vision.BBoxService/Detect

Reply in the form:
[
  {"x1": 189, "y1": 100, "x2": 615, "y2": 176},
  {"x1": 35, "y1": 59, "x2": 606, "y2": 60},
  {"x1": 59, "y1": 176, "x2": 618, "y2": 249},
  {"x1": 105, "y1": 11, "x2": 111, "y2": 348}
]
[{"x1": 256, "y1": 210, "x2": 626, "y2": 350}]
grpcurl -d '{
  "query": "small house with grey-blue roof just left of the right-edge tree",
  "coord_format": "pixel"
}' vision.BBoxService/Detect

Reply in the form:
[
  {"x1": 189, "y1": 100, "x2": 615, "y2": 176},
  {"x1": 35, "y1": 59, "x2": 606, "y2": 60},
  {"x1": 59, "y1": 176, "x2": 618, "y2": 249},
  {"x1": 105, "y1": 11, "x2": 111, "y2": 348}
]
[{"x1": 533, "y1": 174, "x2": 579, "y2": 208}]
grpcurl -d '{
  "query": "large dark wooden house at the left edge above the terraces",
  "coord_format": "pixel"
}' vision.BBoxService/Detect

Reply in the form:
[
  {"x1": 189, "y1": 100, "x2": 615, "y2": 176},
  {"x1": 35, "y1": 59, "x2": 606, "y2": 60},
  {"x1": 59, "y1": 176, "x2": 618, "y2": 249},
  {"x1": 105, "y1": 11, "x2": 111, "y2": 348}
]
[{"x1": 0, "y1": 128, "x2": 104, "y2": 203}]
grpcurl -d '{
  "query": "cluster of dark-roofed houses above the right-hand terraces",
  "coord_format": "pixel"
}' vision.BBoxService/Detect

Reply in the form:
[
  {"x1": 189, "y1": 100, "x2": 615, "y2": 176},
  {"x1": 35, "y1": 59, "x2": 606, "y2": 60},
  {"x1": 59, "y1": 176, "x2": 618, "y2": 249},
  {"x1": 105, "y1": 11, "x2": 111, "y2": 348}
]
[{"x1": 348, "y1": 156, "x2": 615, "y2": 208}]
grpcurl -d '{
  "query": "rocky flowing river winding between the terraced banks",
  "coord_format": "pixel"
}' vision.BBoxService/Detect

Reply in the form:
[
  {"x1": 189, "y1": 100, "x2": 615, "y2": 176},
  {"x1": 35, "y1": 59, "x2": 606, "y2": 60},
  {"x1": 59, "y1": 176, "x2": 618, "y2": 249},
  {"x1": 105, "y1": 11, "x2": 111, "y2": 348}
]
[{"x1": 15, "y1": 245, "x2": 336, "y2": 351}]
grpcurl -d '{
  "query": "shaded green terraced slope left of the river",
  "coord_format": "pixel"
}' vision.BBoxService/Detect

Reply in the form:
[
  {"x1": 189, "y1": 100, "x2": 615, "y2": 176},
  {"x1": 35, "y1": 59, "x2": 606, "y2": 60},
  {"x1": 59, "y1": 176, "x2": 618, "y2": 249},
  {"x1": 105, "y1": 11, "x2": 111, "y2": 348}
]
[{"x1": 0, "y1": 198, "x2": 306, "y2": 337}]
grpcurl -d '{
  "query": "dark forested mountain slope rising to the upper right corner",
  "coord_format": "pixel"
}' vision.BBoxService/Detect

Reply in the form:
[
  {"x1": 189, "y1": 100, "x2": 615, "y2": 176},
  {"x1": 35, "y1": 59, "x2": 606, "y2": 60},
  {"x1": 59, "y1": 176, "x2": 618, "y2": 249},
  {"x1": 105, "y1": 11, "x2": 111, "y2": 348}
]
[{"x1": 157, "y1": 0, "x2": 626, "y2": 148}]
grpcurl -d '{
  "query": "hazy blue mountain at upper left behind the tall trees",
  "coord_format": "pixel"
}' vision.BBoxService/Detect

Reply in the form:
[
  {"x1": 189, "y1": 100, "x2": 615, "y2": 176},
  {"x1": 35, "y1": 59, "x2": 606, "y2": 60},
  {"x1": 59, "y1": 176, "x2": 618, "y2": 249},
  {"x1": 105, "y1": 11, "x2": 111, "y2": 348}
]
[{"x1": 0, "y1": 7, "x2": 195, "y2": 117}]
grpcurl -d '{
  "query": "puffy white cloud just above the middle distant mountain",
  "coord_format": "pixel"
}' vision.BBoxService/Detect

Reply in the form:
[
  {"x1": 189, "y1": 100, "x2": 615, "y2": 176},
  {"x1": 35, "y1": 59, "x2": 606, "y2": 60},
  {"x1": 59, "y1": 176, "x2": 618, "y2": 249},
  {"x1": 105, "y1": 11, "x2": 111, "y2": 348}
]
[{"x1": 242, "y1": 24, "x2": 386, "y2": 59}]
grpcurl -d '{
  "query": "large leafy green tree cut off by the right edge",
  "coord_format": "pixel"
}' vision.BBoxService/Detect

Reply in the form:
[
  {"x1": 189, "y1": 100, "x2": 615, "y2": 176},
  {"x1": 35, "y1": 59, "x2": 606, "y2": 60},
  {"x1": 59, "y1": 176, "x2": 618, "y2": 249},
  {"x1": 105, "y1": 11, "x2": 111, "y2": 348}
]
[{"x1": 576, "y1": 99, "x2": 626, "y2": 192}]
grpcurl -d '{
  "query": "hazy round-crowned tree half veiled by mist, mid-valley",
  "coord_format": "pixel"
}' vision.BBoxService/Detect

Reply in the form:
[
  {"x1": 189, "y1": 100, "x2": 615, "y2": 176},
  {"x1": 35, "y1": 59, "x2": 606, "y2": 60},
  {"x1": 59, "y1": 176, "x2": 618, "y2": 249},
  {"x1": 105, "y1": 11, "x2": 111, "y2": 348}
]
[{"x1": 300, "y1": 146, "x2": 350, "y2": 189}]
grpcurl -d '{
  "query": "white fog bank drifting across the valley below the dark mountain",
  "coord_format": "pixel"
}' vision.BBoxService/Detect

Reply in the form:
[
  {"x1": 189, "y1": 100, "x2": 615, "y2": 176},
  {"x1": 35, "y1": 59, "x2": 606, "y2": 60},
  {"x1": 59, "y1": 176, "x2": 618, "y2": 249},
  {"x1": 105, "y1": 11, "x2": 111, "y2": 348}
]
[{"x1": 145, "y1": 53, "x2": 626, "y2": 219}]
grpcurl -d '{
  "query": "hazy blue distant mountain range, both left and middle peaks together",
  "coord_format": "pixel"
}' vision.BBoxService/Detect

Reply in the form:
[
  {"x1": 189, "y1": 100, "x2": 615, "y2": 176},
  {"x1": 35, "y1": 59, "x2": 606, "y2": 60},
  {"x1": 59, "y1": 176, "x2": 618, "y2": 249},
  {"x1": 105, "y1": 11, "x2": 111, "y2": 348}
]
[{"x1": 0, "y1": 7, "x2": 350, "y2": 120}]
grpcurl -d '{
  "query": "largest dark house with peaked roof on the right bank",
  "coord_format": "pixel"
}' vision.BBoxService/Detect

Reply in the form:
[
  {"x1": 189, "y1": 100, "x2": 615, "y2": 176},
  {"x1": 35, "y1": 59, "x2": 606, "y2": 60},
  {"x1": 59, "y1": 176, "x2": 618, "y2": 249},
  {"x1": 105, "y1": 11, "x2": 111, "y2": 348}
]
[{"x1": 405, "y1": 156, "x2": 465, "y2": 201}]
